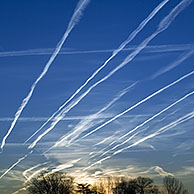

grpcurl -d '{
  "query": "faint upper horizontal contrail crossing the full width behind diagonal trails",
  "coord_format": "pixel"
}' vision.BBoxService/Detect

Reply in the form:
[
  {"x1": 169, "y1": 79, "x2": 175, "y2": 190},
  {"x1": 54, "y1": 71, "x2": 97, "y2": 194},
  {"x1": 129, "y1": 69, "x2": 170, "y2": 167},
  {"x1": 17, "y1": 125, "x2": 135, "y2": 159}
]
[{"x1": 0, "y1": 44, "x2": 194, "y2": 57}]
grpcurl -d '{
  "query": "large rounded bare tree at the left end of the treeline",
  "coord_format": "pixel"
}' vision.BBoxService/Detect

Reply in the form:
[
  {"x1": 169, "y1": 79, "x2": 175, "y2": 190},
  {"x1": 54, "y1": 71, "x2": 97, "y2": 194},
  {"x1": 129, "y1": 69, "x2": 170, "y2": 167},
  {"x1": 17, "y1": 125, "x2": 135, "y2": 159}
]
[{"x1": 28, "y1": 173, "x2": 74, "y2": 194}]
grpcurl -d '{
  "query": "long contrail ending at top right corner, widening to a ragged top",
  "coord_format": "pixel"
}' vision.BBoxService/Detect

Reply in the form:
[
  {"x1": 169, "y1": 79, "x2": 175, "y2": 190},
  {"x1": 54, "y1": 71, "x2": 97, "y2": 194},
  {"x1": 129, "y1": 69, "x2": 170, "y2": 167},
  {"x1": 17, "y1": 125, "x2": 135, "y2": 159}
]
[{"x1": 28, "y1": 0, "x2": 189, "y2": 149}]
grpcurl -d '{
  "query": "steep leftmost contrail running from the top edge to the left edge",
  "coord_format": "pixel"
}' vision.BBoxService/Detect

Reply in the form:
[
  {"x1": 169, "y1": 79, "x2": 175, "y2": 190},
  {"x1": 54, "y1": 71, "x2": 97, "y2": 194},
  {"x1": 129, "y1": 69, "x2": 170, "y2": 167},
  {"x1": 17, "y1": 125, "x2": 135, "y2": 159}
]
[{"x1": 1, "y1": 0, "x2": 89, "y2": 150}]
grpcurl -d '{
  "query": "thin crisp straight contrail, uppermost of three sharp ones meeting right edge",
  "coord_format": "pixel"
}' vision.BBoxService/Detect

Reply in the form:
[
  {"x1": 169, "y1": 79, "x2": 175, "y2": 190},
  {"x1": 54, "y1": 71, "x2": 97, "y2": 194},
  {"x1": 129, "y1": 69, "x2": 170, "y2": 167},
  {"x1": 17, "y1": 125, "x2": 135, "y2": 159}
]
[{"x1": 80, "y1": 71, "x2": 194, "y2": 139}]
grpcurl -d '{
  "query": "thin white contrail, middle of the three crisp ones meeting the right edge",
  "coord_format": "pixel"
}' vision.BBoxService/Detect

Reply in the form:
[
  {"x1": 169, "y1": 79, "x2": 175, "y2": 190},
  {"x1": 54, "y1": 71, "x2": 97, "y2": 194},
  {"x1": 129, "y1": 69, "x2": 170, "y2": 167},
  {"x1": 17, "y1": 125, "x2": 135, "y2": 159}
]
[{"x1": 104, "y1": 91, "x2": 194, "y2": 153}]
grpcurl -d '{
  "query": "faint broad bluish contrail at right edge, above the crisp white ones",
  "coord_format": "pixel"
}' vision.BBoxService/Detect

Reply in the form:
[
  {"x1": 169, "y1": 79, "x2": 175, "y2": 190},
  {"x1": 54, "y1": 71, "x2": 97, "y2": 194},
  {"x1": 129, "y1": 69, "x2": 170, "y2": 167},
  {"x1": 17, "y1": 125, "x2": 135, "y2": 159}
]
[{"x1": 151, "y1": 49, "x2": 194, "y2": 79}]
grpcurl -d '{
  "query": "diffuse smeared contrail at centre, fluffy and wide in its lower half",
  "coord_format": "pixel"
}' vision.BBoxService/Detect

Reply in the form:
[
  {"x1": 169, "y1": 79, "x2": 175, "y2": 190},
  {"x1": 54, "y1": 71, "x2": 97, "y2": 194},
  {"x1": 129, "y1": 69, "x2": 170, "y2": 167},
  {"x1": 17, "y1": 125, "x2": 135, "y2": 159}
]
[{"x1": 44, "y1": 82, "x2": 138, "y2": 153}]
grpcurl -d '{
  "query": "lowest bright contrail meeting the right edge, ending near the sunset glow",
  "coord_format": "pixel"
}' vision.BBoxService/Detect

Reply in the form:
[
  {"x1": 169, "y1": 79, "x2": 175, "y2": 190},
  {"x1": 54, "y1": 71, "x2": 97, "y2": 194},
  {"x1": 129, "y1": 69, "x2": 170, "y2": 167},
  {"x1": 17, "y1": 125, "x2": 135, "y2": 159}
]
[{"x1": 83, "y1": 111, "x2": 194, "y2": 171}]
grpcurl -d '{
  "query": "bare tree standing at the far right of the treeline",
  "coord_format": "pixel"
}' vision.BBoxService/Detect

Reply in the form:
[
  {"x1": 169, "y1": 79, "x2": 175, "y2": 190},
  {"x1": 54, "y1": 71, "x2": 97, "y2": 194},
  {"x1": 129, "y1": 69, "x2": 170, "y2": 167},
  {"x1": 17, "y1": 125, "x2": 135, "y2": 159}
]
[{"x1": 163, "y1": 176, "x2": 188, "y2": 194}]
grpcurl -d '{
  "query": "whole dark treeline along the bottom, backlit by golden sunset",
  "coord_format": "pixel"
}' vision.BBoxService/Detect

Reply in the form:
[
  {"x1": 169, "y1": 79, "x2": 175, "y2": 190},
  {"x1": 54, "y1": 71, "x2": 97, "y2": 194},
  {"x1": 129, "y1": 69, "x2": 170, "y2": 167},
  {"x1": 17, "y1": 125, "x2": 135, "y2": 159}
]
[{"x1": 28, "y1": 172, "x2": 188, "y2": 194}]
